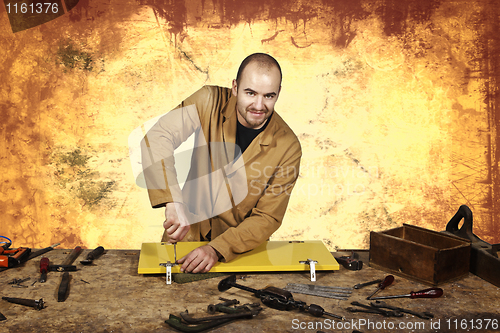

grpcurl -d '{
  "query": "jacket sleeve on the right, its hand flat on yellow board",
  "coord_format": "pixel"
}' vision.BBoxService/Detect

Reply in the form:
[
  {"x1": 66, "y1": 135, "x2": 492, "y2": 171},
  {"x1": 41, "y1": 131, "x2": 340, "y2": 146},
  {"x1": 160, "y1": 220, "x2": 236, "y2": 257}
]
[{"x1": 209, "y1": 140, "x2": 302, "y2": 262}]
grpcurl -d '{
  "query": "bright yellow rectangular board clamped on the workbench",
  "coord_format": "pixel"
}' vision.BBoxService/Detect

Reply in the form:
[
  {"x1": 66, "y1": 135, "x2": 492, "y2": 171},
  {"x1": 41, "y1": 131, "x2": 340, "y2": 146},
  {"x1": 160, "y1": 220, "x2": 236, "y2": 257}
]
[{"x1": 138, "y1": 241, "x2": 339, "y2": 274}]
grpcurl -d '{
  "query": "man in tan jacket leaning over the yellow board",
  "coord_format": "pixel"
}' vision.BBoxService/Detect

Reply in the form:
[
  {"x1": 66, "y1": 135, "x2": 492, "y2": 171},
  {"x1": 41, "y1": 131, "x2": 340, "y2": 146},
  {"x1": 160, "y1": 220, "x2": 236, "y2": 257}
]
[{"x1": 143, "y1": 53, "x2": 302, "y2": 273}]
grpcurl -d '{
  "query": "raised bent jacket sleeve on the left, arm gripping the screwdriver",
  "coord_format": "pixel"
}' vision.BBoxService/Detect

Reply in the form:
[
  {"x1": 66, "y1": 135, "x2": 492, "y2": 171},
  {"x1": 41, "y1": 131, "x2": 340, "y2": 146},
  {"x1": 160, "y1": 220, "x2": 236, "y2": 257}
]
[{"x1": 141, "y1": 87, "x2": 213, "y2": 208}]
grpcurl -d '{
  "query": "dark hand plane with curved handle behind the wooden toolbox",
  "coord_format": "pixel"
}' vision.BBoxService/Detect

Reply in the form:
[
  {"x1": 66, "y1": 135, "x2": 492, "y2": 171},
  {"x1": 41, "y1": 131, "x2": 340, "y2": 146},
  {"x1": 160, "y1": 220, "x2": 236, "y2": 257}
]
[{"x1": 443, "y1": 205, "x2": 500, "y2": 287}]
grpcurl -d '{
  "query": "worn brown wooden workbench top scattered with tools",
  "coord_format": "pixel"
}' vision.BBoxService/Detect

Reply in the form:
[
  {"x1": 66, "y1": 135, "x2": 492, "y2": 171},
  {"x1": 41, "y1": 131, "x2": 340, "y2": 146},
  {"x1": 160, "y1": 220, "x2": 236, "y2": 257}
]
[{"x1": 0, "y1": 249, "x2": 500, "y2": 333}]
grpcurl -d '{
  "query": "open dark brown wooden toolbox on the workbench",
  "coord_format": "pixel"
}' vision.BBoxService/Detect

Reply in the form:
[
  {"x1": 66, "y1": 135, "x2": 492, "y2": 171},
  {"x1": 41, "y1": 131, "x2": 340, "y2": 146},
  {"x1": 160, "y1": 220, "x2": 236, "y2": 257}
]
[{"x1": 370, "y1": 224, "x2": 471, "y2": 285}]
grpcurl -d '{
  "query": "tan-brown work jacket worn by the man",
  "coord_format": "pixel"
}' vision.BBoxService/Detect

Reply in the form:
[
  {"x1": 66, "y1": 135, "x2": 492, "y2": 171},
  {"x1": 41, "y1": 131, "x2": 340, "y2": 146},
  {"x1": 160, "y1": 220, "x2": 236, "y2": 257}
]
[{"x1": 142, "y1": 86, "x2": 302, "y2": 261}]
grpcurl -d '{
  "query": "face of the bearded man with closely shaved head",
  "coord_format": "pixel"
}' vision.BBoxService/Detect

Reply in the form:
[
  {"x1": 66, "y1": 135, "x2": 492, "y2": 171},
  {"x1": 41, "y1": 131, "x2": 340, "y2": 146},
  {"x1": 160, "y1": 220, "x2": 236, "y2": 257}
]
[{"x1": 232, "y1": 62, "x2": 281, "y2": 129}]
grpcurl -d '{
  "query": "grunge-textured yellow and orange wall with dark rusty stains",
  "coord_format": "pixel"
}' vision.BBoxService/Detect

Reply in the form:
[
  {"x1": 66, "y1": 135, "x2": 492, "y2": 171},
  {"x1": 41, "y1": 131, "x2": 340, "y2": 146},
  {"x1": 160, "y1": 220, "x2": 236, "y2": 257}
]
[{"x1": 0, "y1": 0, "x2": 500, "y2": 250}]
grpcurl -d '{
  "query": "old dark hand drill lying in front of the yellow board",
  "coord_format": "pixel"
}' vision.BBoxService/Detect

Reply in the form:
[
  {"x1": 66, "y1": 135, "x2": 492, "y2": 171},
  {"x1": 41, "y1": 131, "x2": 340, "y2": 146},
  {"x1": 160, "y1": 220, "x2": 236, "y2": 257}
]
[{"x1": 218, "y1": 275, "x2": 344, "y2": 320}]
